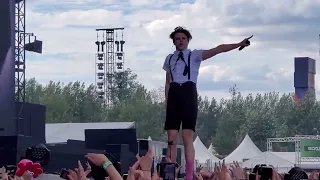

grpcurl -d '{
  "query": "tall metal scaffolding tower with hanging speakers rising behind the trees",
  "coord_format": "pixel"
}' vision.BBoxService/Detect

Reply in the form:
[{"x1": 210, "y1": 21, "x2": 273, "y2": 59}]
[{"x1": 95, "y1": 28, "x2": 125, "y2": 106}]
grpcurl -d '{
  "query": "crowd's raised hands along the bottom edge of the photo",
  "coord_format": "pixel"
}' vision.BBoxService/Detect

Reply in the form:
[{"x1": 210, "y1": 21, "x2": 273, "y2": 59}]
[{"x1": 1, "y1": 148, "x2": 319, "y2": 180}]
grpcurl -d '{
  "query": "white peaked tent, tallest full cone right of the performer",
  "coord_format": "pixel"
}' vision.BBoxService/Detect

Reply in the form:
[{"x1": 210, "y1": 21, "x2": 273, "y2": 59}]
[{"x1": 225, "y1": 135, "x2": 262, "y2": 163}]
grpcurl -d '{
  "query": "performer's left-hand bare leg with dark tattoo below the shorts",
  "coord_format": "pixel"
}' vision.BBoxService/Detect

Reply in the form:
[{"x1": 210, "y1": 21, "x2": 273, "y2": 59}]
[{"x1": 167, "y1": 130, "x2": 179, "y2": 163}]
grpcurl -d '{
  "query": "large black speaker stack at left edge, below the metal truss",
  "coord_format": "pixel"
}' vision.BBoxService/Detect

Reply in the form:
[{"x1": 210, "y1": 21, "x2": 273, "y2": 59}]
[{"x1": 0, "y1": 102, "x2": 46, "y2": 167}]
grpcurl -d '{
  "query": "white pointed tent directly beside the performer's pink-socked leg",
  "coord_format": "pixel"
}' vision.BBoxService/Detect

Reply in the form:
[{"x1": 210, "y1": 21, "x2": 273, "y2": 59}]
[{"x1": 193, "y1": 136, "x2": 220, "y2": 164}]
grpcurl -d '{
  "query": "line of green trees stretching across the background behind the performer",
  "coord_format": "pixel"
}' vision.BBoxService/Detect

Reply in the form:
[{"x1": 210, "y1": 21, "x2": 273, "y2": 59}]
[{"x1": 26, "y1": 70, "x2": 320, "y2": 155}]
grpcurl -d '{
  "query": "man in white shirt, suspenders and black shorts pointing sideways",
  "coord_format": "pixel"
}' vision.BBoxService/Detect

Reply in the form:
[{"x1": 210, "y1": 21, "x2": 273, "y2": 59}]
[{"x1": 163, "y1": 27, "x2": 251, "y2": 180}]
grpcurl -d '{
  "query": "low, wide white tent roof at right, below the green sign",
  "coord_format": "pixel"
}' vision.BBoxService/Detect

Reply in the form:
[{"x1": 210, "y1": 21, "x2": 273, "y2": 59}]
[{"x1": 242, "y1": 152, "x2": 294, "y2": 173}]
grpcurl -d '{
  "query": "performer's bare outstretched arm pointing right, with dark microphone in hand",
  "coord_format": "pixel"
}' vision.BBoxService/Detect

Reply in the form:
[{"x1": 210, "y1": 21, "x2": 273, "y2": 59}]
[{"x1": 202, "y1": 36, "x2": 252, "y2": 60}]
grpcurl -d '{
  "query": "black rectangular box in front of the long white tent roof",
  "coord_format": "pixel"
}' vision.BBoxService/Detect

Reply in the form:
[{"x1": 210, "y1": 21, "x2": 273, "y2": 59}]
[{"x1": 84, "y1": 129, "x2": 138, "y2": 154}]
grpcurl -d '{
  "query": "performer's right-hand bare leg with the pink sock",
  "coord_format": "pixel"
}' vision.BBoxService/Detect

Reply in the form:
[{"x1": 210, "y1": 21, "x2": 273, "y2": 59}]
[{"x1": 182, "y1": 129, "x2": 195, "y2": 180}]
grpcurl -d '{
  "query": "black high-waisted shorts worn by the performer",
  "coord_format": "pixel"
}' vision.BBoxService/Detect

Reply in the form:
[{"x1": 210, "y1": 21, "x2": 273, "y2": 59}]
[{"x1": 164, "y1": 81, "x2": 198, "y2": 131}]
